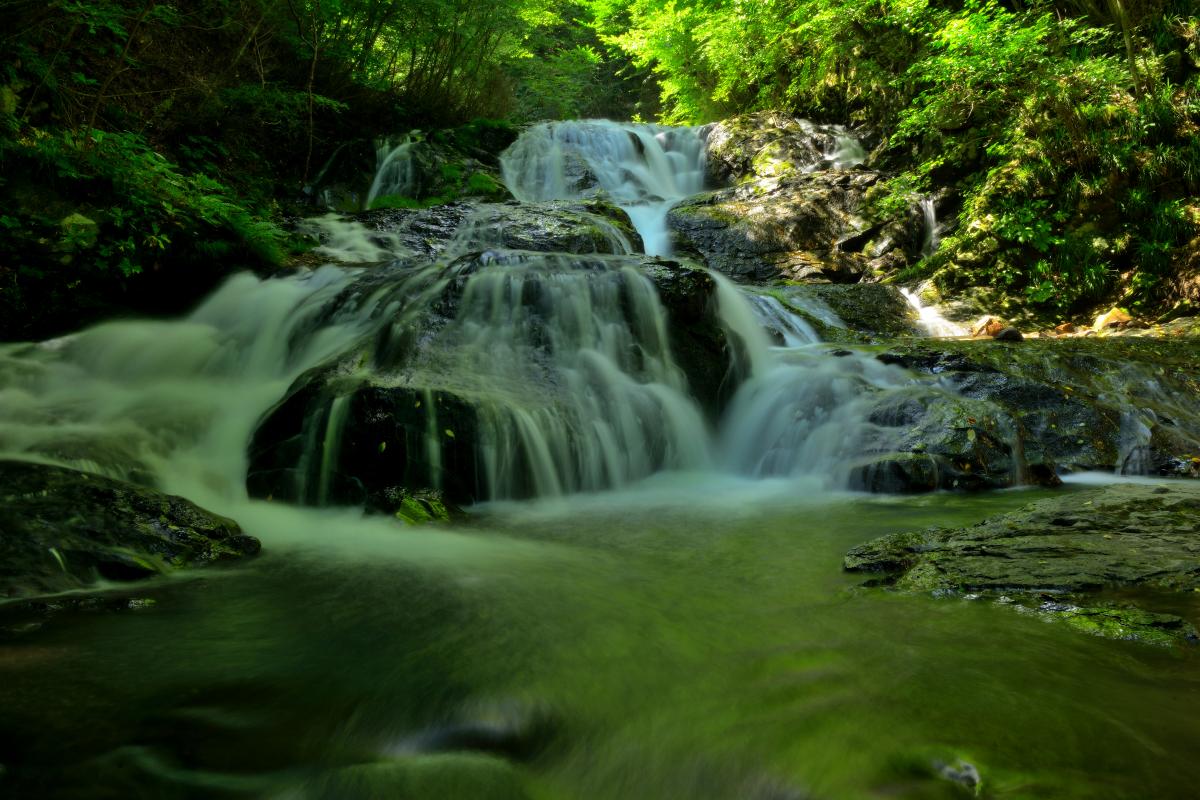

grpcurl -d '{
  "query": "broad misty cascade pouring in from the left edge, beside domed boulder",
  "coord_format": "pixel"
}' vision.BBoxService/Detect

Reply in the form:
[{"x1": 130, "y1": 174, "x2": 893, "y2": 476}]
[{"x1": 0, "y1": 267, "x2": 373, "y2": 507}]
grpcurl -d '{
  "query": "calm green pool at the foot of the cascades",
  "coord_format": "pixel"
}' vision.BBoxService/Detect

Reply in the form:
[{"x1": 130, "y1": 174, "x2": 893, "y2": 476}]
[{"x1": 0, "y1": 476, "x2": 1200, "y2": 800}]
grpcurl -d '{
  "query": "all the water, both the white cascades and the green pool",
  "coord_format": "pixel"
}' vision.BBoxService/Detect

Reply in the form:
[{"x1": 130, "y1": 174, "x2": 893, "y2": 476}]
[{"x1": 0, "y1": 124, "x2": 1200, "y2": 800}]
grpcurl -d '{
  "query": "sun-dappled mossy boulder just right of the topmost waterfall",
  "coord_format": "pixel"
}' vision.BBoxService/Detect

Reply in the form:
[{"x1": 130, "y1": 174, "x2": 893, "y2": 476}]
[{"x1": 668, "y1": 112, "x2": 930, "y2": 283}]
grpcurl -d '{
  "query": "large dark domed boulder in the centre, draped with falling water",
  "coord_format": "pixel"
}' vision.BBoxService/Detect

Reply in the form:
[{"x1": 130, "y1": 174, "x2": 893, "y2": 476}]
[{"x1": 247, "y1": 251, "x2": 736, "y2": 513}]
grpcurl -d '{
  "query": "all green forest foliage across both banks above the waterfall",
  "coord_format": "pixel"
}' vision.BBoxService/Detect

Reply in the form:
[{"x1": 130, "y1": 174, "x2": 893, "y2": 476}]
[{"x1": 0, "y1": 0, "x2": 1200, "y2": 337}]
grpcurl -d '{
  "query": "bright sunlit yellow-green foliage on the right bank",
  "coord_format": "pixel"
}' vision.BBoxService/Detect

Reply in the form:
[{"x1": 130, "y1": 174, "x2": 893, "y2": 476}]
[{"x1": 592, "y1": 0, "x2": 1200, "y2": 313}]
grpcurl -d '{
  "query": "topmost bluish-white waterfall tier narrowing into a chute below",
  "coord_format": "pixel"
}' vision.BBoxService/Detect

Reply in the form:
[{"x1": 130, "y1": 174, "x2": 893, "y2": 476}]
[{"x1": 500, "y1": 120, "x2": 704, "y2": 255}]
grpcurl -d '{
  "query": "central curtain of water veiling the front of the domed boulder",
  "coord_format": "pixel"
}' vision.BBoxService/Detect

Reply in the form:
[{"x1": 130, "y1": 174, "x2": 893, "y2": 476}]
[{"x1": 434, "y1": 253, "x2": 708, "y2": 498}]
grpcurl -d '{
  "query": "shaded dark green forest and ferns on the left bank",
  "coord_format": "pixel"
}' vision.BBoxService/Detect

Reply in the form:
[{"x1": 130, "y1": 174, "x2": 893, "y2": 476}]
[{"x1": 0, "y1": 0, "x2": 628, "y2": 337}]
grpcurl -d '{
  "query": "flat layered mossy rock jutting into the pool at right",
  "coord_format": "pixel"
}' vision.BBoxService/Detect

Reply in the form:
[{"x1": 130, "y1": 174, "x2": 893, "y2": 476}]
[{"x1": 845, "y1": 483, "x2": 1200, "y2": 643}]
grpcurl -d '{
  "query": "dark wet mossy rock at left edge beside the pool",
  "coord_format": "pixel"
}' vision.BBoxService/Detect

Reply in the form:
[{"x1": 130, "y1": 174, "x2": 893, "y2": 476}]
[{"x1": 0, "y1": 461, "x2": 259, "y2": 599}]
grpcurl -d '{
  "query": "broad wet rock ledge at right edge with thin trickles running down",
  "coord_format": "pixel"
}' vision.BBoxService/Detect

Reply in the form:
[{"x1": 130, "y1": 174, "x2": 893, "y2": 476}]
[{"x1": 878, "y1": 338, "x2": 1200, "y2": 476}]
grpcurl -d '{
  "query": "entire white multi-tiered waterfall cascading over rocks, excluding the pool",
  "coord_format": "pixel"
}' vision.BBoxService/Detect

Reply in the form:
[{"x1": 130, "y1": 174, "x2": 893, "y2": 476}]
[{"x1": 0, "y1": 115, "x2": 1032, "y2": 509}]
